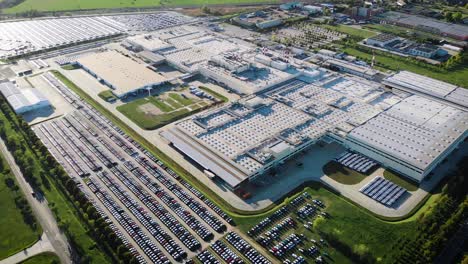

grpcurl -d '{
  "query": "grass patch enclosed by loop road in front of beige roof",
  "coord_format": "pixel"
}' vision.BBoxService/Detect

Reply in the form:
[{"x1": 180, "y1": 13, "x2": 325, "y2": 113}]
[{"x1": 117, "y1": 93, "x2": 206, "y2": 130}]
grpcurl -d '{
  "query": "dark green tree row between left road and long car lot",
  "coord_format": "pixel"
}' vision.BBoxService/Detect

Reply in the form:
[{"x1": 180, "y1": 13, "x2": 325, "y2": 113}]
[{"x1": 0, "y1": 95, "x2": 137, "y2": 263}]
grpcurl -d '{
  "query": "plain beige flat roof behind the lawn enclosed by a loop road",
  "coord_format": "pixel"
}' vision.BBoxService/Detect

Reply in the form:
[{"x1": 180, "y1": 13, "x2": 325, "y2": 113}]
[{"x1": 77, "y1": 51, "x2": 167, "y2": 96}]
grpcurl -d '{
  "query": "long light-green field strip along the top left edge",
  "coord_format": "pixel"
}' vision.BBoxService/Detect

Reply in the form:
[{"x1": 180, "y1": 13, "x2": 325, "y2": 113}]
[{"x1": 1, "y1": 0, "x2": 275, "y2": 13}]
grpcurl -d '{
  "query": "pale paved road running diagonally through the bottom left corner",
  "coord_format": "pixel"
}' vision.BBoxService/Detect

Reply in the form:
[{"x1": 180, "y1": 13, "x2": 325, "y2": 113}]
[{"x1": 0, "y1": 139, "x2": 72, "y2": 263}]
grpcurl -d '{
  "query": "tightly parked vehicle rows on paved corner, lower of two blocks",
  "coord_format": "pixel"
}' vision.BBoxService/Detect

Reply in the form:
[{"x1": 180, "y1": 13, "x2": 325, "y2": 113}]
[{"x1": 359, "y1": 176, "x2": 407, "y2": 206}]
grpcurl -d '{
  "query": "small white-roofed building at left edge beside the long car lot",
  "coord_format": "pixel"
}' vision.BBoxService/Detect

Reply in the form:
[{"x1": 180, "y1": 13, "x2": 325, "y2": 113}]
[{"x1": 0, "y1": 82, "x2": 50, "y2": 114}]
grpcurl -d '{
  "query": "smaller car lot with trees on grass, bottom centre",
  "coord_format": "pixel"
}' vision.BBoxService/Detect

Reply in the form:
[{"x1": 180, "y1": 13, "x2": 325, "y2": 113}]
[{"x1": 245, "y1": 192, "x2": 341, "y2": 264}]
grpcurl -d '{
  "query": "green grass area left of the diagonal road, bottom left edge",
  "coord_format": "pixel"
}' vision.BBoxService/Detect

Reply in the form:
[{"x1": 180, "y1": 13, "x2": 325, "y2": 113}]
[{"x1": 0, "y1": 156, "x2": 42, "y2": 260}]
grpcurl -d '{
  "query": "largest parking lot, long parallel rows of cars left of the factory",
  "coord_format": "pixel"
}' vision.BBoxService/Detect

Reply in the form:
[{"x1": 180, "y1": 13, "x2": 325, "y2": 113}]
[{"x1": 33, "y1": 73, "x2": 256, "y2": 263}]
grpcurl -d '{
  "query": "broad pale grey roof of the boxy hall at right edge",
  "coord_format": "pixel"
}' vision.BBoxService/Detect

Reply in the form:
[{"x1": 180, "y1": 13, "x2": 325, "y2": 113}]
[{"x1": 348, "y1": 95, "x2": 468, "y2": 170}]
